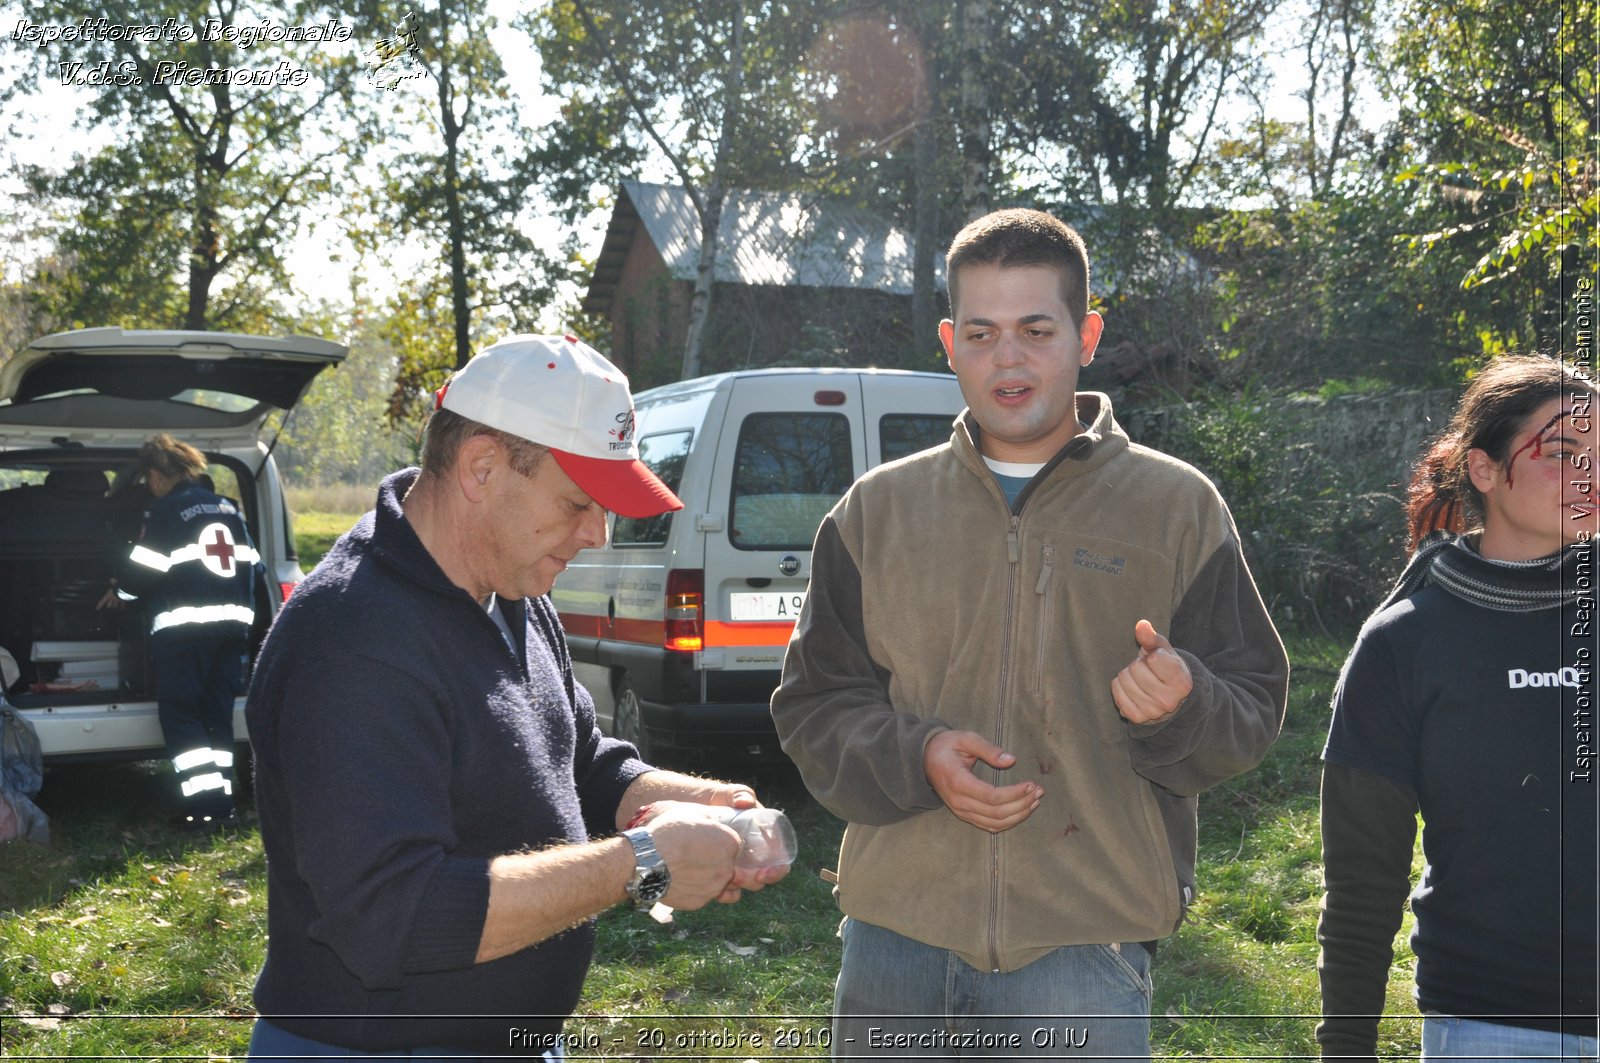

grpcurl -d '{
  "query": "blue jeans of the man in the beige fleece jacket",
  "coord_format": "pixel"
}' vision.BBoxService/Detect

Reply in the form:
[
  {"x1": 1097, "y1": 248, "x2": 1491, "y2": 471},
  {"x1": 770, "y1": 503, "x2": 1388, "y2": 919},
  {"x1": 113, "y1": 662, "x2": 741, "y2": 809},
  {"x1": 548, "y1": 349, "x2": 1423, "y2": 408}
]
[{"x1": 834, "y1": 919, "x2": 1150, "y2": 1060}]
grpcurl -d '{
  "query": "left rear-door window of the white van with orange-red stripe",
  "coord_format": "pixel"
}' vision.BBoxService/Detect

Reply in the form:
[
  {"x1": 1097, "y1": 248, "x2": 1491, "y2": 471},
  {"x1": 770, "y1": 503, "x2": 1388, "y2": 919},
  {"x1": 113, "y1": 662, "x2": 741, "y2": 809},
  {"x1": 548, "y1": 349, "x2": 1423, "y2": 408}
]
[{"x1": 728, "y1": 413, "x2": 854, "y2": 549}]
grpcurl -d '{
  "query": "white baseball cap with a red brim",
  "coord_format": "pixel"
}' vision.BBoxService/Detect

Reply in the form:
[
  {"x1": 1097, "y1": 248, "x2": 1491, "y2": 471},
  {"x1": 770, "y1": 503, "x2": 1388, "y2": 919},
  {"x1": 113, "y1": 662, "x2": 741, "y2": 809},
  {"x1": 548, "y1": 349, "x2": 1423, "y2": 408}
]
[{"x1": 437, "y1": 335, "x2": 683, "y2": 517}]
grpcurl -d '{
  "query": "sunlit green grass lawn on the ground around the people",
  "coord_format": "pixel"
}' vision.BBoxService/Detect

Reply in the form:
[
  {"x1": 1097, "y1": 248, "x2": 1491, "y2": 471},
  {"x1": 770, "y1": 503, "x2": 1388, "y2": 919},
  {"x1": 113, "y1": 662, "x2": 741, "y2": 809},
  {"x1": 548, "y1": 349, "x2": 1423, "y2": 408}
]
[{"x1": 0, "y1": 514, "x2": 1418, "y2": 1060}]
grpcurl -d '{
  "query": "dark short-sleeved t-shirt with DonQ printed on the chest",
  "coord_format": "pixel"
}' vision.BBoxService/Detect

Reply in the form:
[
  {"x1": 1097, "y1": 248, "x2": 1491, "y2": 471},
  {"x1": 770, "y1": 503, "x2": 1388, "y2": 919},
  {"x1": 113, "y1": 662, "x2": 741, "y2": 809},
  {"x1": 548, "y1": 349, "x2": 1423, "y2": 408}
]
[{"x1": 1323, "y1": 586, "x2": 1600, "y2": 1036}]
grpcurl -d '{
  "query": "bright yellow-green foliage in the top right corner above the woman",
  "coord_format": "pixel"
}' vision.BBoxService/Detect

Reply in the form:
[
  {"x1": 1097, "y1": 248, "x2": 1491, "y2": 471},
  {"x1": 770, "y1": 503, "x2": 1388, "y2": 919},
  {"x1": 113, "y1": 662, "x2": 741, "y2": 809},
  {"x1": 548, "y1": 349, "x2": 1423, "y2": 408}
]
[{"x1": 1395, "y1": 0, "x2": 1600, "y2": 336}]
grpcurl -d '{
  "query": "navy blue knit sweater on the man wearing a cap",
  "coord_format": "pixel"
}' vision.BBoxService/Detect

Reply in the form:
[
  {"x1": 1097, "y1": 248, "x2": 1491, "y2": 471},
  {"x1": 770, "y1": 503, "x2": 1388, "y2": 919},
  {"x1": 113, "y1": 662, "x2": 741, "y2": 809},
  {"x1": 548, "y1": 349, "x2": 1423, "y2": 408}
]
[{"x1": 246, "y1": 471, "x2": 648, "y2": 1053}]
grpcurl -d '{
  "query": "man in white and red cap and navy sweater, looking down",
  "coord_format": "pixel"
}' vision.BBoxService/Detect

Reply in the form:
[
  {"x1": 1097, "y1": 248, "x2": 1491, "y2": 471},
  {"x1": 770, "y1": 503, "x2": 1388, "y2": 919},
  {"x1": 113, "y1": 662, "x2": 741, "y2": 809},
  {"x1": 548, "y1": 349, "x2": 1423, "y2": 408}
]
[{"x1": 246, "y1": 336, "x2": 782, "y2": 1058}]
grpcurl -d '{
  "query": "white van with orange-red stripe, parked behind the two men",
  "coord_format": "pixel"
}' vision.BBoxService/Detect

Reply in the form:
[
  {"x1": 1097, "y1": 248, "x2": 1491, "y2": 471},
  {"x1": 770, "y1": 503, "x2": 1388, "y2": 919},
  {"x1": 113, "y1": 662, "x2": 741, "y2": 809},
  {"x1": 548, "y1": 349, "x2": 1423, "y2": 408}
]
[{"x1": 552, "y1": 368, "x2": 963, "y2": 760}]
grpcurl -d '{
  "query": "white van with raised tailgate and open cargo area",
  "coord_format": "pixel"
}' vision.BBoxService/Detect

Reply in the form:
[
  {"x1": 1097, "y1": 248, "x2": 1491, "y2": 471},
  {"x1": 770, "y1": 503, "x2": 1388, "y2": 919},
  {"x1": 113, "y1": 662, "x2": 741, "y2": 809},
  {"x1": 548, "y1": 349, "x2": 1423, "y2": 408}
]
[{"x1": 0, "y1": 328, "x2": 346, "y2": 764}]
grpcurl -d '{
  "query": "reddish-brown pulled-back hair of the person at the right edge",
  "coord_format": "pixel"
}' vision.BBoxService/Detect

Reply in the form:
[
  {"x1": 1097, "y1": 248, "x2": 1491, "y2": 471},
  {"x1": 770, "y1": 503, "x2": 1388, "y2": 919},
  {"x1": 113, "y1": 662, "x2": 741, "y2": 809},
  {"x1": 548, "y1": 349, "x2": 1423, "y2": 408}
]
[{"x1": 1406, "y1": 354, "x2": 1600, "y2": 551}]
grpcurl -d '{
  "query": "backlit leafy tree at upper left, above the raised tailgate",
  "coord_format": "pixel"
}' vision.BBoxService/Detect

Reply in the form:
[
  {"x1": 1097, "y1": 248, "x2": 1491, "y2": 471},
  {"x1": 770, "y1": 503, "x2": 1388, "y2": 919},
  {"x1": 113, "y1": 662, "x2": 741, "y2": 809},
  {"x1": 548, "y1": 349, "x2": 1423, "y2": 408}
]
[{"x1": 6, "y1": 0, "x2": 363, "y2": 331}]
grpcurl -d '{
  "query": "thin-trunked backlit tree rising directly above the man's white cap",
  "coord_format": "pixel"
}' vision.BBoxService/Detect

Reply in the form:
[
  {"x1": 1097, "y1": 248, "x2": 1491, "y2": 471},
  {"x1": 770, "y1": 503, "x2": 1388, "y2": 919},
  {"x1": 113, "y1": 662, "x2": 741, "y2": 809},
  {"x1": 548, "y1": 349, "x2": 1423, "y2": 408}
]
[{"x1": 360, "y1": 0, "x2": 576, "y2": 409}]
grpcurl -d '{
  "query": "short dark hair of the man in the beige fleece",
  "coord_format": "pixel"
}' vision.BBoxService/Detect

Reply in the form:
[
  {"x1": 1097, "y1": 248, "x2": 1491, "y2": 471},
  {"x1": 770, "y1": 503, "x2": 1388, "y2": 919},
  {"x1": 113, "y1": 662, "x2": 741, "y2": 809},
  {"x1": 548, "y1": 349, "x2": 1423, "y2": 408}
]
[{"x1": 944, "y1": 207, "x2": 1090, "y2": 328}]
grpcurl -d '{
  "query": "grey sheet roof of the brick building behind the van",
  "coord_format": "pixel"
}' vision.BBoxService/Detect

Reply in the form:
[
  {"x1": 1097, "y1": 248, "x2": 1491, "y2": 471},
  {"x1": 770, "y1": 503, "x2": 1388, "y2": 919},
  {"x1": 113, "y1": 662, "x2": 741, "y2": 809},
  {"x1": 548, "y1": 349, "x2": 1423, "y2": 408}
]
[{"x1": 584, "y1": 181, "x2": 944, "y2": 312}]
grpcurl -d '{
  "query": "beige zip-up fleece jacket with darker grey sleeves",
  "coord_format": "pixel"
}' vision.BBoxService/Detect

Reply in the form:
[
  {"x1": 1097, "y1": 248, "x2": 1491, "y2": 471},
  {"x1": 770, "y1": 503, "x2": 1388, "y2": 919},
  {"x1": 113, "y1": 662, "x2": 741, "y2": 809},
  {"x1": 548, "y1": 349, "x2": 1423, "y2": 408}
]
[{"x1": 771, "y1": 394, "x2": 1288, "y2": 970}]
